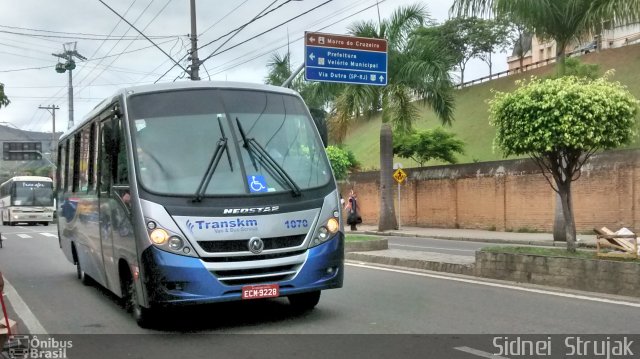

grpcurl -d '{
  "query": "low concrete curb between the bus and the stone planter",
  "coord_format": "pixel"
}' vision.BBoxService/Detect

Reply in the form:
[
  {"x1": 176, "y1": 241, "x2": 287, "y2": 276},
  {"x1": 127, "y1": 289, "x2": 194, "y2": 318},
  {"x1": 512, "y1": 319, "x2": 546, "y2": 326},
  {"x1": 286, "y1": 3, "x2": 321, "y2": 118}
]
[{"x1": 345, "y1": 252, "x2": 475, "y2": 276}]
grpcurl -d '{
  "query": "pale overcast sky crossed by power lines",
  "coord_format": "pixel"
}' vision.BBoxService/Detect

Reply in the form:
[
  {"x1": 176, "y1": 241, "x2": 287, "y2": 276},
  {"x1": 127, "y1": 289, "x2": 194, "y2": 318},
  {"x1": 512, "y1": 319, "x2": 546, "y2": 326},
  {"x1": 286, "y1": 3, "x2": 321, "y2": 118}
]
[{"x1": 0, "y1": 0, "x2": 507, "y2": 136}]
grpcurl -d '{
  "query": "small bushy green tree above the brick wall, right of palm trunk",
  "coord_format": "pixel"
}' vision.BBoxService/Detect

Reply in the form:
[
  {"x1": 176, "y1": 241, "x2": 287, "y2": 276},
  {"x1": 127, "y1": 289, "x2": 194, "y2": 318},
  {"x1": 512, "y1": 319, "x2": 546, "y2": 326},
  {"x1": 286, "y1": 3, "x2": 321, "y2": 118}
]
[{"x1": 393, "y1": 127, "x2": 464, "y2": 167}]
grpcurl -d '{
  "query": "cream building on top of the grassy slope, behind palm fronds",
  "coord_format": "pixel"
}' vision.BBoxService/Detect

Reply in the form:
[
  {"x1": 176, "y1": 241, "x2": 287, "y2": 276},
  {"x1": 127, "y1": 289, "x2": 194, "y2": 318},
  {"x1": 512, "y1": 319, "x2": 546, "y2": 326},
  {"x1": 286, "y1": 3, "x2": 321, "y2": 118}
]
[{"x1": 507, "y1": 23, "x2": 640, "y2": 71}]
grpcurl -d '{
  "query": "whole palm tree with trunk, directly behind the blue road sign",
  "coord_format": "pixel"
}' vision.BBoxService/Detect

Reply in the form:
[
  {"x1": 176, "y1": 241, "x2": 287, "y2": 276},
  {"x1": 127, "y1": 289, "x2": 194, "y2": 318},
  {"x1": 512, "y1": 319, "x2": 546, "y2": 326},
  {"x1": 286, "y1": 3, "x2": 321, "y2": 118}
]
[{"x1": 331, "y1": 5, "x2": 454, "y2": 230}]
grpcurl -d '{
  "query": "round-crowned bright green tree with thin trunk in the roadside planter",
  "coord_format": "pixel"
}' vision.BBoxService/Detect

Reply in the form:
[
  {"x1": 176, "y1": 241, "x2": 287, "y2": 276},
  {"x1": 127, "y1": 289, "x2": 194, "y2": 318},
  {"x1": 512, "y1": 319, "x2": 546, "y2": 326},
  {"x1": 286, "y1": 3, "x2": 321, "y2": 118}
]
[{"x1": 490, "y1": 76, "x2": 639, "y2": 251}]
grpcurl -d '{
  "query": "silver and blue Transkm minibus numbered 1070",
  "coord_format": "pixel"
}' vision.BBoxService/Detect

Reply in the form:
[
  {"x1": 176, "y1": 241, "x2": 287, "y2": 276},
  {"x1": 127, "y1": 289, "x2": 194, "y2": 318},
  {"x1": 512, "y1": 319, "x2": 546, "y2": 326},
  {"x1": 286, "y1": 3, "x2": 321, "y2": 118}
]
[{"x1": 57, "y1": 82, "x2": 344, "y2": 326}]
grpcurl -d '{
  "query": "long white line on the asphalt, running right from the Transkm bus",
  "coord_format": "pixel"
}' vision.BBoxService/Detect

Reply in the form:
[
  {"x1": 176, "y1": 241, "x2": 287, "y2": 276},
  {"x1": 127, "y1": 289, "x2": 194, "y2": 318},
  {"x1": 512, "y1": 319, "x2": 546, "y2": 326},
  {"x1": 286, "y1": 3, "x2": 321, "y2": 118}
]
[{"x1": 345, "y1": 263, "x2": 640, "y2": 308}]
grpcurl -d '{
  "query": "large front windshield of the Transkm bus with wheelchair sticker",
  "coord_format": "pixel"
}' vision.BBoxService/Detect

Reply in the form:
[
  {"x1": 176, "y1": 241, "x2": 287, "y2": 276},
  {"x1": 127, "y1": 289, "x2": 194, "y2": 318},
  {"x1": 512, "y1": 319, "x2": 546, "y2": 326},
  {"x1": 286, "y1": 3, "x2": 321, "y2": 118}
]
[{"x1": 128, "y1": 89, "x2": 331, "y2": 196}]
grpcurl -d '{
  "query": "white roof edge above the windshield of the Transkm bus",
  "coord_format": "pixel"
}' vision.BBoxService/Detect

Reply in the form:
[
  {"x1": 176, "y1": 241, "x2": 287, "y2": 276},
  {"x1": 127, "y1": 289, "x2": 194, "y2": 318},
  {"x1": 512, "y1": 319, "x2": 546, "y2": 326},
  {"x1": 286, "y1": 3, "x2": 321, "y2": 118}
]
[{"x1": 60, "y1": 81, "x2": 300, "y2": 140}]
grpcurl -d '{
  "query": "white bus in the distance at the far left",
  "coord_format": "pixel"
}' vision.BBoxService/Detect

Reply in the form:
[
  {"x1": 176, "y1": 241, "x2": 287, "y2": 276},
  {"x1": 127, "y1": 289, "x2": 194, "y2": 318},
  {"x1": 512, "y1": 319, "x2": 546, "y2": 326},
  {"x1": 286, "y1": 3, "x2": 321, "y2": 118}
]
[{"x1": 0, "y1": 176, "x2": 54, "y2": 226}]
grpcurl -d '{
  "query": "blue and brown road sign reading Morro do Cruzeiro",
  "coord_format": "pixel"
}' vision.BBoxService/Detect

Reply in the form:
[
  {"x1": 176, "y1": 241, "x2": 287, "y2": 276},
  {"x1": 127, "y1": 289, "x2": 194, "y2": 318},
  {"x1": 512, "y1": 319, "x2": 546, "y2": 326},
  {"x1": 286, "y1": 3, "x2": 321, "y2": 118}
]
[{"x1": 305, "y1": 32, "x2": 388, "y2": 86}]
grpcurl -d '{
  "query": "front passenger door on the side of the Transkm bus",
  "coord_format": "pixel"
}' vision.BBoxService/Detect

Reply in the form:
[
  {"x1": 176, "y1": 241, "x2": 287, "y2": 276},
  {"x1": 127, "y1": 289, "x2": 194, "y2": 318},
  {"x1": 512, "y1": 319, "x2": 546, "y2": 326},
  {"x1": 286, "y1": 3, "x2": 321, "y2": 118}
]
[{"x1": 99, "y1": 119, "x2": 136, "y2": 296}]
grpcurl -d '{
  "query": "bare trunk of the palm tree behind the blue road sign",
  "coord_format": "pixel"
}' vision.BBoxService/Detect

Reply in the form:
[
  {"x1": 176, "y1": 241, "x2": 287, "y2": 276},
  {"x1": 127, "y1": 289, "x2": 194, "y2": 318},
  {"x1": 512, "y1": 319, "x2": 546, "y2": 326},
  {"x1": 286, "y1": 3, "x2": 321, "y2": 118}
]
[{"x1": 378, "y1": 123, "x2": 398, "y2": 231}]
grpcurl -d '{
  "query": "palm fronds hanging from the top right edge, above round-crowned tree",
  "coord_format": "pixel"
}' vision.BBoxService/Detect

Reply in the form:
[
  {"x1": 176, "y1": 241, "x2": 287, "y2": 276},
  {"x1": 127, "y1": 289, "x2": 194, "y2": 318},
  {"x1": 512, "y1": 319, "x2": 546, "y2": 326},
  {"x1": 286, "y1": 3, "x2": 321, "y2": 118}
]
[{"x1": 451, "y1": 0, "x2": 640, "y2": 75}]
